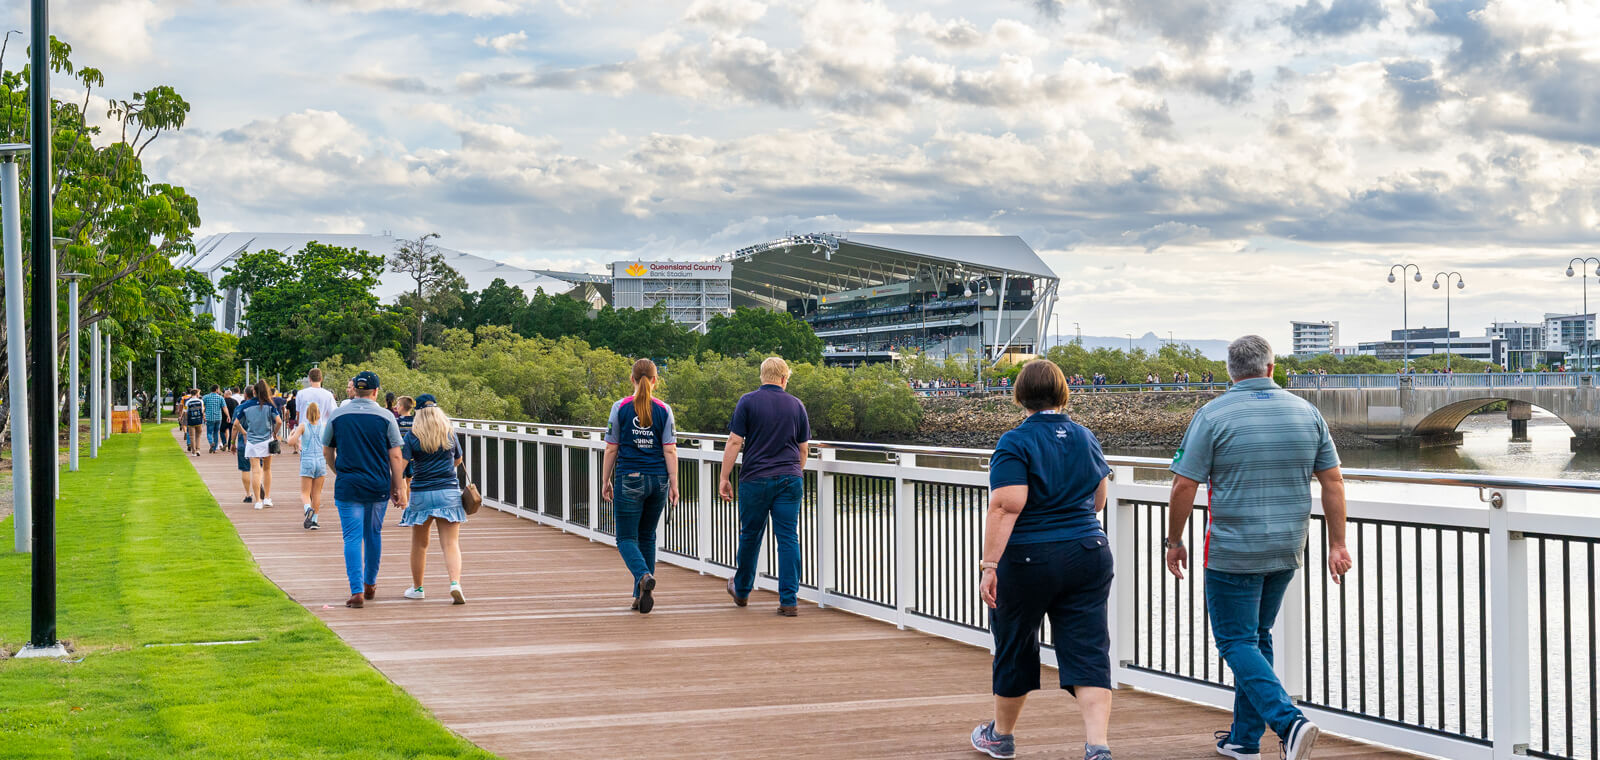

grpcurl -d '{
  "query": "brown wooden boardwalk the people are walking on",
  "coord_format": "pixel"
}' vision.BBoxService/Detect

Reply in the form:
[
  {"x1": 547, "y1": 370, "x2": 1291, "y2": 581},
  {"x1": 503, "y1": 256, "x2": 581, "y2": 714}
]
[{"x1": 179, "y1": 438, "x2": 1410, "y2": 760}]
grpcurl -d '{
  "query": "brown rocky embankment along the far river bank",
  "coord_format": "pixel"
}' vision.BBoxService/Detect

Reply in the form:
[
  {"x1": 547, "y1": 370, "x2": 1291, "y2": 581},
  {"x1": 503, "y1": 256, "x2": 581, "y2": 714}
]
[{"x1": 896, "y1": 392, "x2": 1376, "y2": 451}]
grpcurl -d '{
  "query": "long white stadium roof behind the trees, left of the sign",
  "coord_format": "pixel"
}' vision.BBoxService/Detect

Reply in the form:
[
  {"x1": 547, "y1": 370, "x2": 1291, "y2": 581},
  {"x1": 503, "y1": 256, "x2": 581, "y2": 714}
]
[{"x1": 173, "y1": 232, "x2": 573, "y2": 302}]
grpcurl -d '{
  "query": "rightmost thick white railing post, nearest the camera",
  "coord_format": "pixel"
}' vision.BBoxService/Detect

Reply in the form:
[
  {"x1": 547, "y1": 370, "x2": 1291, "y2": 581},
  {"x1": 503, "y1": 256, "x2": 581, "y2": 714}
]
[{"x1": 1488, "y1": 491, "x2": 1531, "y2": 760}]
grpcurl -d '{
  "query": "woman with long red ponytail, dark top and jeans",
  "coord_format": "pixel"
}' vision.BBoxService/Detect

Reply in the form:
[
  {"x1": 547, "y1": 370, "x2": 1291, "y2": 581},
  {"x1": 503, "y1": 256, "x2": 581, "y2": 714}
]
[{"x1": 600, "y1": 358, "x2": 678, "y2": 613}]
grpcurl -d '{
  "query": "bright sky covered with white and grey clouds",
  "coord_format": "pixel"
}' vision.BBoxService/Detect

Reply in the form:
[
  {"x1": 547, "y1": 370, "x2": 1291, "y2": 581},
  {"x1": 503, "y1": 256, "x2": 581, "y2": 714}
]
[{"x1": 0, "y1": 0, "x2": 1600, "y2": 350}]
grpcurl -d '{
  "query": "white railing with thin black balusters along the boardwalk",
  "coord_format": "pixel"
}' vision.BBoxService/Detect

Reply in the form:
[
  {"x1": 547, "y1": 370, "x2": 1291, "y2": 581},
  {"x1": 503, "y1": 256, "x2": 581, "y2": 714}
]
[{"x1": 458, "y1": 421, "x2": 1600, "y2": 760}]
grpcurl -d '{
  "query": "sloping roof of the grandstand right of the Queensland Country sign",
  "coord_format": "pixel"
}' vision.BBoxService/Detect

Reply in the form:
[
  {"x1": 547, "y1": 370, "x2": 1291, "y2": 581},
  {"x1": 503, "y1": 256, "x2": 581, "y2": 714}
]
[{"x1": 718, "y1": 232, "x2": 1056, "y2": 307}]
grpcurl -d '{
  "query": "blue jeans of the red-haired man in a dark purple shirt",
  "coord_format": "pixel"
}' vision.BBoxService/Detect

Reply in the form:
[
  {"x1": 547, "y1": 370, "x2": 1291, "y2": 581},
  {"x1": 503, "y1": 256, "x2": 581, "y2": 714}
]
[{"x1": 733, "y1": 475, "x2": 805, "y2": 606}]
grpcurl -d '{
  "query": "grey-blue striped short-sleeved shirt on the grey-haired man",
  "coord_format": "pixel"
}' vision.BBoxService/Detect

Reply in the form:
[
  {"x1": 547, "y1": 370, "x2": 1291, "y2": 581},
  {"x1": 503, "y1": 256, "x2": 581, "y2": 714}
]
[{"x1": 1171, "y1": 378, "x2": 1339, "y2": 574}]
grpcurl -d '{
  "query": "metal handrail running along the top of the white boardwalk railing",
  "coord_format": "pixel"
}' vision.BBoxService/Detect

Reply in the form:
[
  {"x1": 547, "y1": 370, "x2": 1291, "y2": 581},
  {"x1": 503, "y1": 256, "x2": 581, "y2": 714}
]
[{"x1": 453, "y1": 419, "x2": 1600, "y2": 494}]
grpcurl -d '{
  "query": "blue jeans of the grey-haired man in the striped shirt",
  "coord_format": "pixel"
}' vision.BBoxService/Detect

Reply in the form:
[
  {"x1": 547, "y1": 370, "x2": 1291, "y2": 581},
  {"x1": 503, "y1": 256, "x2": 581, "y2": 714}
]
[{"x1": 1205, "y1": 570, "x2": 1304, "y2": 749}]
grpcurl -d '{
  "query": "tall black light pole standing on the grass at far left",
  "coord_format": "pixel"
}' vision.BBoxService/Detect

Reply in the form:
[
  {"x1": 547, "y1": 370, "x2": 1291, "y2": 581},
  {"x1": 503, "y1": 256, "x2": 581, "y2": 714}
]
[{"x1": 21, "y1": 0, "x2": 67, "y2": 658}]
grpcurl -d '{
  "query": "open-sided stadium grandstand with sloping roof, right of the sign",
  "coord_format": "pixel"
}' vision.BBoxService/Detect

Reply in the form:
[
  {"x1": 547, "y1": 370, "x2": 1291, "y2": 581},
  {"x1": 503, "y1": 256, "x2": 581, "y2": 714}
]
[{"x1": 718, "y1": 232, "x2": 1059, "y2": 365}]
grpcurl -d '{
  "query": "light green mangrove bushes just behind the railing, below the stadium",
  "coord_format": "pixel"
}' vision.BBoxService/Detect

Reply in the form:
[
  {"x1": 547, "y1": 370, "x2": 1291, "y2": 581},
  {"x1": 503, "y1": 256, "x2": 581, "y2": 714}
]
[{"x1": 322, "y1": 325, "x2": 922, "y2": 438}]
